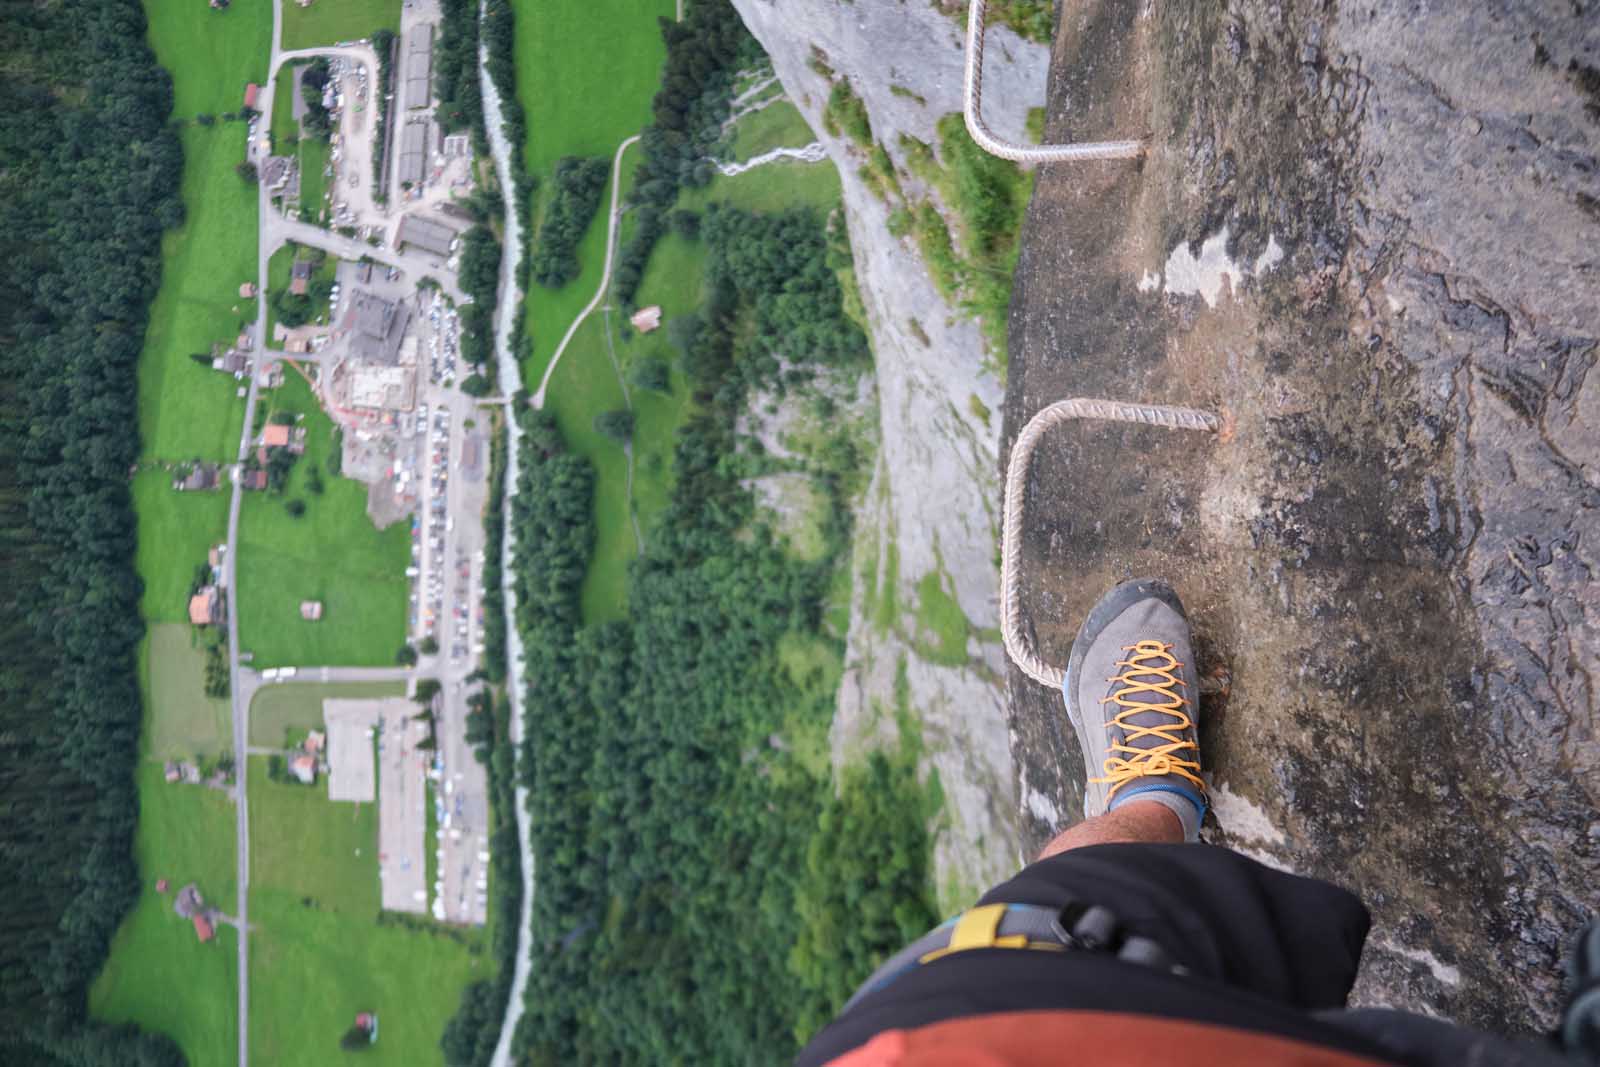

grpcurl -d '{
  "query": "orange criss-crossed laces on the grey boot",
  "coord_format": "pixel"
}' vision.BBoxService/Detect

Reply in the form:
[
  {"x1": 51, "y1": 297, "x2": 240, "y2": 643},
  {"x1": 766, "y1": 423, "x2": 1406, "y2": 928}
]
[{"x1": 1090, "y1": 641, "x2": 1205, "y2": 800}]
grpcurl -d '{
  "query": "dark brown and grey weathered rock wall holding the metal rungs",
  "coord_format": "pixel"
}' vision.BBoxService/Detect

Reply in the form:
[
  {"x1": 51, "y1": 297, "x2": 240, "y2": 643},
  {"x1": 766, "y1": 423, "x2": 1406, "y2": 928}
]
[{"x1": 1005, "y1": 0, "x2": 1600, "y2": 1029}]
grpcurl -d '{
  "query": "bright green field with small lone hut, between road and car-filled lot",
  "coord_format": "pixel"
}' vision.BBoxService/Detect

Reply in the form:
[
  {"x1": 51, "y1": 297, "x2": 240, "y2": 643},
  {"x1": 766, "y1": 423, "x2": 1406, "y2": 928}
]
[{"x1": 235, "y1": 368, "x2": 411, "y2": 659}]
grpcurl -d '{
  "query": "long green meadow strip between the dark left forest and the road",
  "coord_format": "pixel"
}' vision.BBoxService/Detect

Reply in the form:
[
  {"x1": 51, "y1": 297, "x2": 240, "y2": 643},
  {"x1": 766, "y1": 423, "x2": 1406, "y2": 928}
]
[{"x1": 90, "y1": 0, "x2": 272, "y2": 1064}]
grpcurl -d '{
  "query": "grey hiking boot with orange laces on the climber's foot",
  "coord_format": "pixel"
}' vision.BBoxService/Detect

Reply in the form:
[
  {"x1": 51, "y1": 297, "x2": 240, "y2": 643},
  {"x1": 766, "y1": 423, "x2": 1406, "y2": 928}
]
[{"x1": 1061, "y1": 577, "x2": 1205, "y2": 841}]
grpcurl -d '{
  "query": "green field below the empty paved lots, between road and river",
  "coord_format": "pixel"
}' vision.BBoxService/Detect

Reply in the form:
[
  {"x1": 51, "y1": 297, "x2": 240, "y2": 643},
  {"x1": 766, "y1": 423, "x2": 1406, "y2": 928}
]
[{"x1": 250, "y1": 757, "x2": 491, "y2": 1064}]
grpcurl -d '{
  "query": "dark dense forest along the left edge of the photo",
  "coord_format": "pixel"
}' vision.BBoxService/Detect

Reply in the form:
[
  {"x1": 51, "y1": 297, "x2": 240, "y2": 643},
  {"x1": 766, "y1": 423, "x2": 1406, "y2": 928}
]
[{"x1": 0, "y1": 0, "x2": 193, "y2": 1067}]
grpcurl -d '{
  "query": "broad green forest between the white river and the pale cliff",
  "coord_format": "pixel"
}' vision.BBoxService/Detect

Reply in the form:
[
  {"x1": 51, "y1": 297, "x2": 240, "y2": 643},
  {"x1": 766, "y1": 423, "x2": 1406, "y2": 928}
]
[{"x1": 512, "y1": 208, "x2": 934, "y2": 1064}]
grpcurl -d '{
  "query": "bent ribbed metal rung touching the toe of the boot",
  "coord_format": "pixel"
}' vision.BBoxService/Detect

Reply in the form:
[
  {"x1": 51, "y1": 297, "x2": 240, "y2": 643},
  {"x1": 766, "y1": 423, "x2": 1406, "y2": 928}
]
[{"x1": 1004, "y1": 396, "x2": 1226, "y2": 691}]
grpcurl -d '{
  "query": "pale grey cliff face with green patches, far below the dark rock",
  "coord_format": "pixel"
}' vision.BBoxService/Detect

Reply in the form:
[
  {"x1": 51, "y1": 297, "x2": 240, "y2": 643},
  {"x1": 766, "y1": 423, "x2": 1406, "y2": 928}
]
[{"x1": 734, "y1": 0, "x2": 1048, "y2": 907}]
